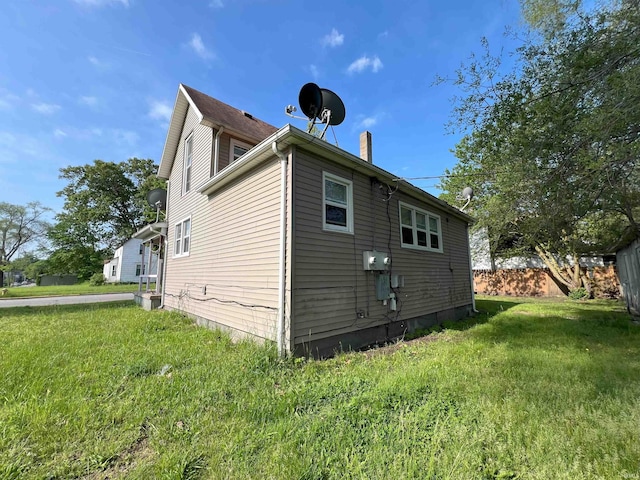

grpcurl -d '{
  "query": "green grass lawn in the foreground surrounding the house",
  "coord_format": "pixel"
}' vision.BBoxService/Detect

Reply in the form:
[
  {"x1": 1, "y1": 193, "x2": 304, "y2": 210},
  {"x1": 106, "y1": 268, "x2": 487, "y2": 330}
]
[{"x1": 0, "y1": 298, "x2": 640, "y2": 480}]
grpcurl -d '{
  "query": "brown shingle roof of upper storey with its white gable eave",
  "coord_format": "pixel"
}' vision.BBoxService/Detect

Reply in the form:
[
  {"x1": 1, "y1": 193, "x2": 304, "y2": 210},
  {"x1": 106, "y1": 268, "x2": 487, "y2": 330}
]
[{"x1": 158, "y1": 84, "x2": 278, "y2": 179}]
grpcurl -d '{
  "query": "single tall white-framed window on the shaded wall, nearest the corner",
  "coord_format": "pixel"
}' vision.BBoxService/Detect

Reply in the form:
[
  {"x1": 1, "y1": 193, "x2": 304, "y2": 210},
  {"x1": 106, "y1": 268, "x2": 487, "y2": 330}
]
[{"x1": 322, "y1": 172, "x2": 353, "y2": 233}]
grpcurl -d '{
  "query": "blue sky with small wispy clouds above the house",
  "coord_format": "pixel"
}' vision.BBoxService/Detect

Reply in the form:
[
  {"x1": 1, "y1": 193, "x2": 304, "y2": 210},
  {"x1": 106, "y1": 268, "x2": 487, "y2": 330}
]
[{"x1": 0, "y1": 0, "x2": 520, "y2": 214}]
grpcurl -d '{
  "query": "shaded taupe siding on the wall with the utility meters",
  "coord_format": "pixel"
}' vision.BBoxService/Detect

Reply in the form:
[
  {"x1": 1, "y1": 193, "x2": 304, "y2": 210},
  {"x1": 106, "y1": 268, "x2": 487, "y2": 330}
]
[{"x1": 293, "y1": 149, "x2": 471, "y2": 344}]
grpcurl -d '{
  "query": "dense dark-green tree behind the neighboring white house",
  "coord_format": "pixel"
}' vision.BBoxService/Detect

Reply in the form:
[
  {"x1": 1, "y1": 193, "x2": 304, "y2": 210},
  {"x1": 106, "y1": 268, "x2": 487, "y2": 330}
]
[{"x1": 49, "y1": 158, "x2": 164, "y2": 279}]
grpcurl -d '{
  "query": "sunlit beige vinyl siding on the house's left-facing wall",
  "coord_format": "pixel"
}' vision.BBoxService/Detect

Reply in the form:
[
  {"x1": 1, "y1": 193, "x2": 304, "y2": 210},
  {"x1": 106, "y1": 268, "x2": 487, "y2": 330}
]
[{"x1": 164, "y1": 107, "x2": 280, "y2": 339}]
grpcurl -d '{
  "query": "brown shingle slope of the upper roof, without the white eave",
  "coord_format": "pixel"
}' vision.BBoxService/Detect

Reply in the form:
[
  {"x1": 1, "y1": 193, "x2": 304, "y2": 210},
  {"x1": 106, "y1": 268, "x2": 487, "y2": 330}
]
[{"x1": 182, "y1": 84, "x2": 278, "y2": 142}]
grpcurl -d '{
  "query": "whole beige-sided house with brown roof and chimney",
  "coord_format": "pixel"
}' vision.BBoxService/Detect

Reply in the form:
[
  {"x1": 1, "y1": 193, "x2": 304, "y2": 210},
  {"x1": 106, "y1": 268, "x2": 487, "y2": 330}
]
[{"x1": 158, "y1": 85, "x2": 473, "y2": 355}]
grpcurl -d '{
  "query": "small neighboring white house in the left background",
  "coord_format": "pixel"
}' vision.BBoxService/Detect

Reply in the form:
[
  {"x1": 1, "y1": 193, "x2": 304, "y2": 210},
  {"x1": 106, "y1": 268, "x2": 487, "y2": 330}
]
[{"x1": 102, "y1": 238, "x2": 157, "y2": 283}]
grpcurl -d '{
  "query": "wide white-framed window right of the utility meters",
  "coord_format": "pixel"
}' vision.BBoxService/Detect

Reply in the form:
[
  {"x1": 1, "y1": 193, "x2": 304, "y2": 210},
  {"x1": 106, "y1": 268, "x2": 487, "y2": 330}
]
[{"x1": 399, "y1": 202, "x2": 442, "y2": 252}]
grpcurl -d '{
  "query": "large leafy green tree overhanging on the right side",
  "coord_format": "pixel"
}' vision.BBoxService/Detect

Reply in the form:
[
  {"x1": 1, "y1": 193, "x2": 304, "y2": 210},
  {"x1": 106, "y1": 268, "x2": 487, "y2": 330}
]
[{"x1": 442, "y1": 1, "x2": 640, "y2": 290}]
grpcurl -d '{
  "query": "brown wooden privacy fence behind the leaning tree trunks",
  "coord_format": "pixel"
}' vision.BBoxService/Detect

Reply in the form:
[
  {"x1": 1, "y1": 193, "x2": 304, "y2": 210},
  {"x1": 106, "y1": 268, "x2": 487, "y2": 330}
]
[{"x1": 473, "y1": 265, "x2": 620, "y2": 298}]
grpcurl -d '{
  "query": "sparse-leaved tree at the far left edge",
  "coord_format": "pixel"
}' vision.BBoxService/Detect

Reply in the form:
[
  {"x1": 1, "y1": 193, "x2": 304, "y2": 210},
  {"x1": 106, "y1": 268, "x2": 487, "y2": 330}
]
[{"x1": 0, "y1": 202, "x2": 51, "y2": 286}]
